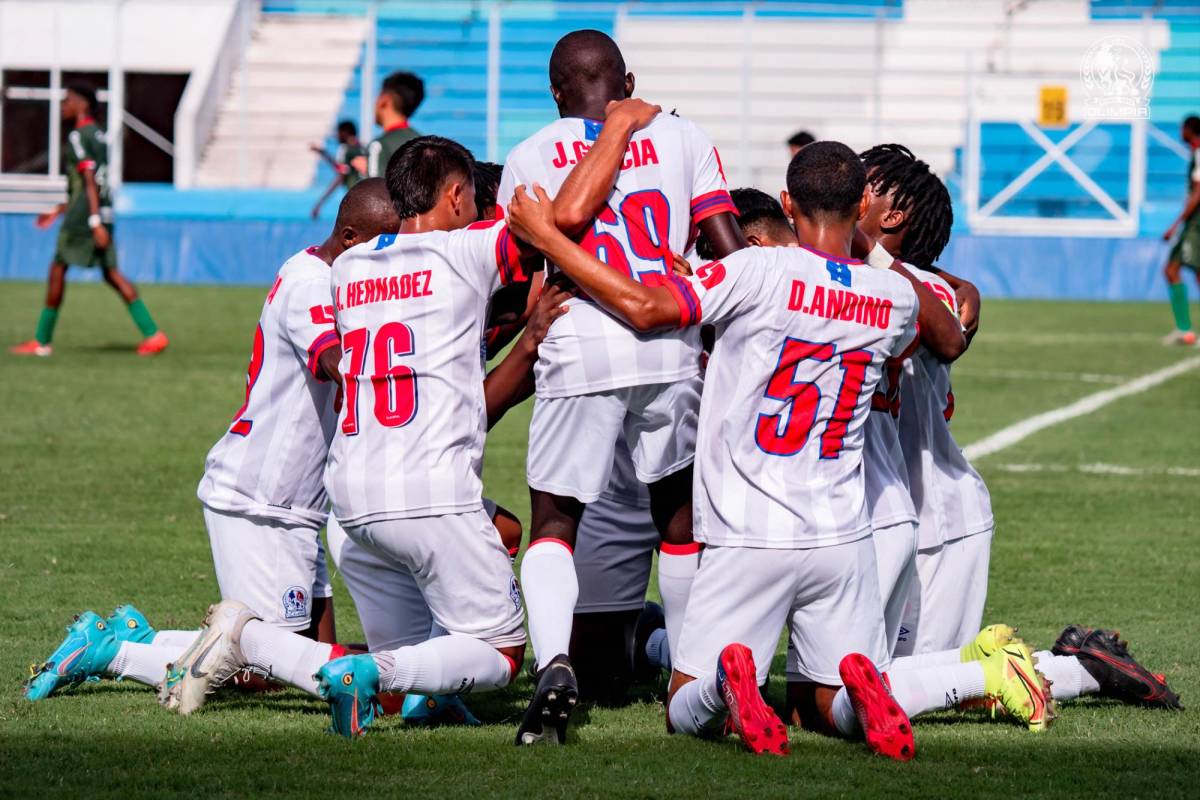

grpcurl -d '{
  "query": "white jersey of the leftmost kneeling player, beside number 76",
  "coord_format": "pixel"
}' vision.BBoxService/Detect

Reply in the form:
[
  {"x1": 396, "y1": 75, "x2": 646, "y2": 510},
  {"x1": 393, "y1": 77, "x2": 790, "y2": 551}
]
[{"x1": 196, "y1": 247, "x2": 337, "y2": 528}]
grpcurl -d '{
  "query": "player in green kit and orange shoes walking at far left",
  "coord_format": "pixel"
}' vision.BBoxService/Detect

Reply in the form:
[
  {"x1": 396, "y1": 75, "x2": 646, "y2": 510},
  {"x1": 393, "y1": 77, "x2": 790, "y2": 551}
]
[{"x1": 10, "y1": 85, "x2": 168, "y2": 356}]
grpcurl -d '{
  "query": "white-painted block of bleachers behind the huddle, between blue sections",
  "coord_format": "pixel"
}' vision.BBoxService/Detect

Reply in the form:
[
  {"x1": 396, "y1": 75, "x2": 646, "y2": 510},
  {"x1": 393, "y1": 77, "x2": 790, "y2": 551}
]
[{"x1": 617, "y1": 0, "x2": 1169, "y2": 193}]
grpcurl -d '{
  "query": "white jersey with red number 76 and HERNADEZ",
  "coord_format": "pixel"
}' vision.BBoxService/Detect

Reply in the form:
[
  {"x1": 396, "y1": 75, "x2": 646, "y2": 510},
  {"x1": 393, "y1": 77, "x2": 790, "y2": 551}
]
[{"x1": 325, "y1": 222, "x2": 524, "y2": 525}]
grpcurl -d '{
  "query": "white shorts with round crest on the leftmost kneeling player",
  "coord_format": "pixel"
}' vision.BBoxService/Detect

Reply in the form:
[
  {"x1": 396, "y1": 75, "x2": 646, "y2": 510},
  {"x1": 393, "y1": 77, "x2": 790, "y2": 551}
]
[{"x1": 204, "y1": 506, "x2": 334, "y2": 631}]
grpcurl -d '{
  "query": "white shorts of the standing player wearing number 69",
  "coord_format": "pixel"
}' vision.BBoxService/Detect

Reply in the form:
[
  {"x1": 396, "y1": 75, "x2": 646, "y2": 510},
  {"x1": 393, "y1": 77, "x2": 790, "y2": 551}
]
[{"x1": 526, "y1": 375, "x2": 702, "y2": 503}]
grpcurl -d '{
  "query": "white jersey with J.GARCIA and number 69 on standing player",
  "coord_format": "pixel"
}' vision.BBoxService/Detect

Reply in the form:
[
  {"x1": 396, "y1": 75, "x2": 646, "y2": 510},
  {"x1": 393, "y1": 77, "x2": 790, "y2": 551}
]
[{"x1": 497, "y1": 114, "x2": 737, "y2": 397}]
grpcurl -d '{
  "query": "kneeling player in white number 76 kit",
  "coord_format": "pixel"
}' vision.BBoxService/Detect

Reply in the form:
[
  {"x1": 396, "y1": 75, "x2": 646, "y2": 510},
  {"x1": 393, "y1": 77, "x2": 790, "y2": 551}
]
[{"x1": 154, "y1": 122, "x2": 656, "y2": 736}]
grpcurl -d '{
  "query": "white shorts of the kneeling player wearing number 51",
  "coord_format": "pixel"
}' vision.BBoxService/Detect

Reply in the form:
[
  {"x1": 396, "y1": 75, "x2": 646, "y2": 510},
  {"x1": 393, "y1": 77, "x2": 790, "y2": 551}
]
[{"x1": 671, "y1": 536, "x2": 889, "y2": 686}]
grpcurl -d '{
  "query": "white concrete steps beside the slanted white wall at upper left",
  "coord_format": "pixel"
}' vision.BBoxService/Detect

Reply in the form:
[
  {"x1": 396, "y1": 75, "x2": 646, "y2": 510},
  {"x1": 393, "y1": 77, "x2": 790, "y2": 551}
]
[{"x1": 196, "y1": 14, "x2": 366, "y2": 190}]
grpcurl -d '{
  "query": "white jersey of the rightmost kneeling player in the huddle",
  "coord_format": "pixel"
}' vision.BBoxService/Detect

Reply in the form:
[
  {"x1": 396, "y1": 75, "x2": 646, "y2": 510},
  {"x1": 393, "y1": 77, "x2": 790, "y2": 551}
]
[{"x1": 900, "y1": 266, "x2": 994, "y2": 549}]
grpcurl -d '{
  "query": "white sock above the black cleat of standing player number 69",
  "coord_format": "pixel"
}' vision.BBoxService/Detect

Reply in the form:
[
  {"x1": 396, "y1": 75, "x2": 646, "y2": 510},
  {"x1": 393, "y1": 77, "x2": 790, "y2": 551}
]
[{"x1": 521, "y1": 539, "x2": 580, "y2": 669}]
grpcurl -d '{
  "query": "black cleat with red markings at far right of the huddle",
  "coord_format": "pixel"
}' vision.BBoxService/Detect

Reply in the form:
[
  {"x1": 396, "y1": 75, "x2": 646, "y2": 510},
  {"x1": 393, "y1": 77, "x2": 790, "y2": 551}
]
[{"x1": 1050, "y1": 625, "x2": 1183, "y2": 711}]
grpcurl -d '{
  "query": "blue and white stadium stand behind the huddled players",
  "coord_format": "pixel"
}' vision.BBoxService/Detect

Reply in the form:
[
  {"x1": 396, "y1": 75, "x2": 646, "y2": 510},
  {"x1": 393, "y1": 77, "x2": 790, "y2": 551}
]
[{"x1": 265, "y1": 0, "x2": 1200, "y2": 235}]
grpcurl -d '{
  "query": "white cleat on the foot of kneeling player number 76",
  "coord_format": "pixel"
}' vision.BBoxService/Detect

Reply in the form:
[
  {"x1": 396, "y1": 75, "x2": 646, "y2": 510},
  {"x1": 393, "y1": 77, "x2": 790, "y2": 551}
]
[{"x1": 158, "y1": 600, "x2": 260, "y2": 714}]
